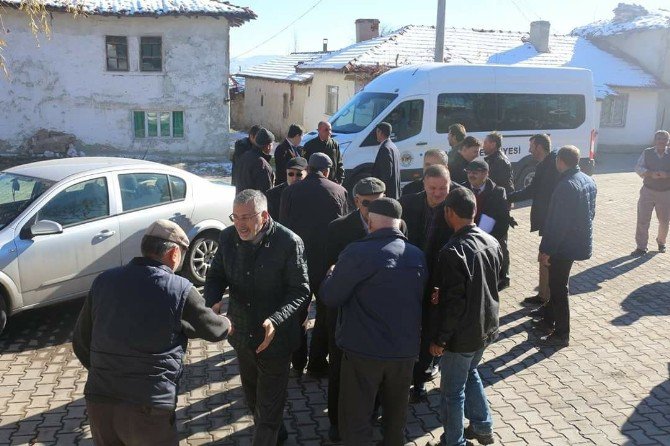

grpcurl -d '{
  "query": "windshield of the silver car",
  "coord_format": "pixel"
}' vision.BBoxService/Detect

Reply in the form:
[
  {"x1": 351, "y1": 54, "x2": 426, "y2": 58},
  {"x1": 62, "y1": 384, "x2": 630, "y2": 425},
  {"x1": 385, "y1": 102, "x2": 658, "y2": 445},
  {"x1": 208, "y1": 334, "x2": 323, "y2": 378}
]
[{"x1": 0, "y1": 172, "x2": 54, "y2": 229}]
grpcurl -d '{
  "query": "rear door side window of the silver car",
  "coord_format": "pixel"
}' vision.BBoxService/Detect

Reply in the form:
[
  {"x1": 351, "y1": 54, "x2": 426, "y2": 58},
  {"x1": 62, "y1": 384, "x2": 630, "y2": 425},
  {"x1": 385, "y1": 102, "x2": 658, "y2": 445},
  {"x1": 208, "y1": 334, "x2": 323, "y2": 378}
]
[{"x1": 119, "y1": 173, "x2": 170, "y2": 211}]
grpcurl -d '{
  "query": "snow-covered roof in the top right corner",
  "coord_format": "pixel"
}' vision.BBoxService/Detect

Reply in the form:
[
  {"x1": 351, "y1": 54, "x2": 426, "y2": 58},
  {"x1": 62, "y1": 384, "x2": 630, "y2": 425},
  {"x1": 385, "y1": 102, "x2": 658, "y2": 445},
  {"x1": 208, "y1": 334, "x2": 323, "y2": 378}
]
[{"x1": 571, "y1": 3, "x2": 670, "y2": 38}]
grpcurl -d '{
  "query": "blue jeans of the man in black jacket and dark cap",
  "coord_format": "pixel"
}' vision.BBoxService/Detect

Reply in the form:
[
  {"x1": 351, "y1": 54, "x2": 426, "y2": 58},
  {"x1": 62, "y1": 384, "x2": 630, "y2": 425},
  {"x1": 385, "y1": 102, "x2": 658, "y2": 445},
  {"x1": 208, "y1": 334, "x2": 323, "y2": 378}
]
[{"x1": 440, "y1": 348, "x2": 493, "y2": 446}]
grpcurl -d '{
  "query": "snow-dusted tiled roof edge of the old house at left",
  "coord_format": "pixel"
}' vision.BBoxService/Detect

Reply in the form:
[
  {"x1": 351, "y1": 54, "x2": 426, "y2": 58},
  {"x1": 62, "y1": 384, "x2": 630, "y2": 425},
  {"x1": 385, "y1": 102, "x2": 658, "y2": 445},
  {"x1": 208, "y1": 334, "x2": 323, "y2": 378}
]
[{"x1": 0, "y1": 0, "x2": 257, "y2": 26}]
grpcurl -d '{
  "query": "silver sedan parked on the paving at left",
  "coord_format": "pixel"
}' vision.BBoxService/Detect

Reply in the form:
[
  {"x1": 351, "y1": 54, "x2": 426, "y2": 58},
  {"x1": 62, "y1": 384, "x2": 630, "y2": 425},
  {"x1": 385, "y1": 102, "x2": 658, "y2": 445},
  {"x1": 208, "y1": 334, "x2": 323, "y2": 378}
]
[{"x1": 0, "y1": 157, "x2": 235, "y2": 331}]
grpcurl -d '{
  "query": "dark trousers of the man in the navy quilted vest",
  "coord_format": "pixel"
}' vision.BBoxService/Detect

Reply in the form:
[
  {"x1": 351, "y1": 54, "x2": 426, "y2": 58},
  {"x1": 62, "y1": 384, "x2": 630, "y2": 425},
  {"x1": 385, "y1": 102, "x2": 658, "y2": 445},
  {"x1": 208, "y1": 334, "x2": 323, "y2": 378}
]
[{"x1": 86, "y1": 400, "x2": 179, "y2": 446}]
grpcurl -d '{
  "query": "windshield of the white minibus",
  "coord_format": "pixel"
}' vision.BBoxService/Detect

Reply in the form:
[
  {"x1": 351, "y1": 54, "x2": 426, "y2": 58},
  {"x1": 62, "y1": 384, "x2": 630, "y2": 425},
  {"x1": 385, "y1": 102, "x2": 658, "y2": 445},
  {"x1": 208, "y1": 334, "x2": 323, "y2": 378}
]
[{"x1": 330, "y1": 92, "x2": 398, "y2": 133}]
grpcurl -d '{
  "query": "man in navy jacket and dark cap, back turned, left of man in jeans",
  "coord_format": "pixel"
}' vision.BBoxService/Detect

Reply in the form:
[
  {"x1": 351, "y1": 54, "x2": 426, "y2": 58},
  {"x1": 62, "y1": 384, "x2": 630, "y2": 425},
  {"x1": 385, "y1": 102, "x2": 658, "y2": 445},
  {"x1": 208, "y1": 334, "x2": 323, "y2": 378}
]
[{"x1": 321, "y1": 197, "x2": 428, "y2": 446}]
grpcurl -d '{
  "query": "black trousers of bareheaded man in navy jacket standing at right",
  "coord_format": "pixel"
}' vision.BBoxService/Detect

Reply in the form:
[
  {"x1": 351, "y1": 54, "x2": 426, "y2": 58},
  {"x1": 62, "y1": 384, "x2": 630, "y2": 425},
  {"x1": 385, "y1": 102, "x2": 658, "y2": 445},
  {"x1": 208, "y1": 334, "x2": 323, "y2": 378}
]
[{"x1": 545, "y1": 257, "x2": 574, "y2": 337}]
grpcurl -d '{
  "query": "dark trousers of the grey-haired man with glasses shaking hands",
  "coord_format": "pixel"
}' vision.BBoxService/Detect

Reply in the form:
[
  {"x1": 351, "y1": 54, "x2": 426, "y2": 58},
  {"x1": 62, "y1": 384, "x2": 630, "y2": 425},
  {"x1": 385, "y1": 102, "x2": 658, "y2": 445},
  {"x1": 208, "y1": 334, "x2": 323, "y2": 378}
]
[{"x1": 235, "y1": 347, "x2": 291, "y2": 446}]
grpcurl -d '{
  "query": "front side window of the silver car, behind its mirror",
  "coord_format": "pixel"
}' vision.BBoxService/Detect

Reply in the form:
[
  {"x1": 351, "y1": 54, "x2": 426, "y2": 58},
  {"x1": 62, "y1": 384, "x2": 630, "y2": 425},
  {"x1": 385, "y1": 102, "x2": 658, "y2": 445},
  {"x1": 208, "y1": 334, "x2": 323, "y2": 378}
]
[{"x1": 37, "y1": 178, "x2": 109, "y2": 227}]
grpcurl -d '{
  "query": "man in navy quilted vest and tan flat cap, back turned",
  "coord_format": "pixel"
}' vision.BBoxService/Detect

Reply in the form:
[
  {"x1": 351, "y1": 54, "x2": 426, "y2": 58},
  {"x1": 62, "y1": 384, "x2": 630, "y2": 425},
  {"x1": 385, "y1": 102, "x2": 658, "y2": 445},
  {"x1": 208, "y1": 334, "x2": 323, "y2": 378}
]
[{"x1": 72, "y1": 220, "x2": 231, "y2": 446}]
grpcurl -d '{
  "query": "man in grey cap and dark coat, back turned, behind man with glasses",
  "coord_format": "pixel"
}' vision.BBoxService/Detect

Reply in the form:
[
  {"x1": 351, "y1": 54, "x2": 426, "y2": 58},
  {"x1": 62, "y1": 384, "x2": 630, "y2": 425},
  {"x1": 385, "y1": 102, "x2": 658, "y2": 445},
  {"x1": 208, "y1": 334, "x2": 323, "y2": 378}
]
[{"x1": 279, "y1": 152, "x2": 348, "y2": 378}]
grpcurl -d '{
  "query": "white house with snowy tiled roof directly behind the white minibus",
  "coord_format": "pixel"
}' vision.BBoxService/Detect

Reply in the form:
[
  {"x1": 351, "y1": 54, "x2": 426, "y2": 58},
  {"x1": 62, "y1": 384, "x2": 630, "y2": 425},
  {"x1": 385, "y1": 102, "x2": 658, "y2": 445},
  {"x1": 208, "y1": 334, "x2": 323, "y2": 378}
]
[{"x1": 242, "y1": 22, "x2": 665, "y2": 148}]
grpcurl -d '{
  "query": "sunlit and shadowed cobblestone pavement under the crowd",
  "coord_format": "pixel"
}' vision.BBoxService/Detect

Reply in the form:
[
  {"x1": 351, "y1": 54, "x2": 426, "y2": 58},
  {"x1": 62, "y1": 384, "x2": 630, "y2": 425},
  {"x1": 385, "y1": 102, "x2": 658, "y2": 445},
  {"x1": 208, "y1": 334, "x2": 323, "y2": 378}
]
[{"x1": 0, "y1": 160, "x2": 670, "y2": 446}]
